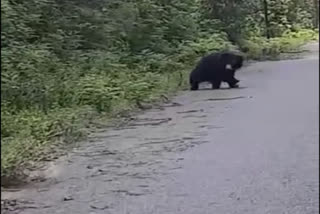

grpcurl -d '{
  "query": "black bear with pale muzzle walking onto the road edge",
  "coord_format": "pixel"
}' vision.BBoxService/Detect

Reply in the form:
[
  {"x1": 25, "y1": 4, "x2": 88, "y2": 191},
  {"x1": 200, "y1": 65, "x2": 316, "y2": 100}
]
[{"x1": 189, "y1": 52, "x2": 244, "y2": 90}]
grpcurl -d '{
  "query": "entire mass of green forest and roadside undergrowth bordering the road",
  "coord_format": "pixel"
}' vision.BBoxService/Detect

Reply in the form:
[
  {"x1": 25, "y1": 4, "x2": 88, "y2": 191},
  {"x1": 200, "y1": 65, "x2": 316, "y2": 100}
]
[{"x1": 1, "y1": 0, "x2": 319, "y2": 178}]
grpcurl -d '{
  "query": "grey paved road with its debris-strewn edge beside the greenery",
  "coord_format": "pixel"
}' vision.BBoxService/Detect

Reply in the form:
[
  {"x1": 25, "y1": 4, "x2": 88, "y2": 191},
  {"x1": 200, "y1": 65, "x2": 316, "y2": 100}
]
[{"x1": 4, "y1": 44, "x2": 319, "y2": 214}]
